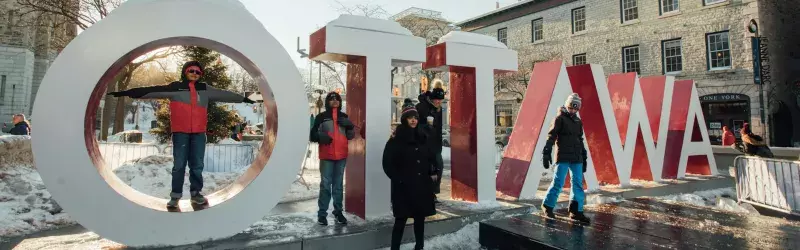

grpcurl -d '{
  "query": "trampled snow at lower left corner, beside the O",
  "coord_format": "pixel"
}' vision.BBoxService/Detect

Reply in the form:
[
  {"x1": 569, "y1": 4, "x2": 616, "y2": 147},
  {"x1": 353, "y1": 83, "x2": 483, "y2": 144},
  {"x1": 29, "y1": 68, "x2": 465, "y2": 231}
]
[{"x1": 0, "y1": 166, "x2": 75, "y2": 237}]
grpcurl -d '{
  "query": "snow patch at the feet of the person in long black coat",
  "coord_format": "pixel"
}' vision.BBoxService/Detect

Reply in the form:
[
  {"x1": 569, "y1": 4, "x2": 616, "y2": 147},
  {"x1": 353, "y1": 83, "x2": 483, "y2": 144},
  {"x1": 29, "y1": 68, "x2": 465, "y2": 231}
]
[{"x1": 381, "y1": 222, "x2": 481, "y2": 250}]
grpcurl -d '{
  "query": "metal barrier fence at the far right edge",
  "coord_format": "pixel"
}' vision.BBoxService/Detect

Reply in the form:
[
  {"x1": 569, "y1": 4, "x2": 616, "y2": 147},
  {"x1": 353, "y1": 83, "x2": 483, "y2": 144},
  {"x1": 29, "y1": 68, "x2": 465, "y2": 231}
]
[{"x1": 734, "y1": 156, "x2": 800, "y2": 215}]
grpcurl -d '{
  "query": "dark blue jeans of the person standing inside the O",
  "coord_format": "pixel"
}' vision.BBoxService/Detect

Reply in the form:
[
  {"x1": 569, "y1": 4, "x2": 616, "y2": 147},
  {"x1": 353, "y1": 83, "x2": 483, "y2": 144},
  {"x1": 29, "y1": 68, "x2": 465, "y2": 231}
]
[{"x1": 170, "y1": 133, "x2": 206, "y2": 198}]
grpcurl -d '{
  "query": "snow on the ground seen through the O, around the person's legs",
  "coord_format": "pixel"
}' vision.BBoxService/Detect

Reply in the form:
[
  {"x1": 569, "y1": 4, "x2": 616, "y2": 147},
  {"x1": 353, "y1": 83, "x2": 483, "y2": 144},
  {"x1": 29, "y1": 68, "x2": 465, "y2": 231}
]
[{"x1": 114, "y1": 155, "x2": 241, "y2": 199}]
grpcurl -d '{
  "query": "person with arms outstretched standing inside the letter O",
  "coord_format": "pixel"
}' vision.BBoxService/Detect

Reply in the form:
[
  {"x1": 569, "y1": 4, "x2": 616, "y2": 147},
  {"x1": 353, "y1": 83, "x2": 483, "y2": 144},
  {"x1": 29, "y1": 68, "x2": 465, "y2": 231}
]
[{"x1": 109, "y1": 61, "x2": 255, "y2": 209}]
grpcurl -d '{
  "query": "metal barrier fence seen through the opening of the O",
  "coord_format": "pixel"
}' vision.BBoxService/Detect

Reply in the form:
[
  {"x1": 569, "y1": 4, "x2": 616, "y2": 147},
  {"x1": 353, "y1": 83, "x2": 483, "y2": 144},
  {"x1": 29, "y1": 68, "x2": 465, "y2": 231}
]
[{"x1": 99, "y1": 143, "x2": 258, "y2": 172}]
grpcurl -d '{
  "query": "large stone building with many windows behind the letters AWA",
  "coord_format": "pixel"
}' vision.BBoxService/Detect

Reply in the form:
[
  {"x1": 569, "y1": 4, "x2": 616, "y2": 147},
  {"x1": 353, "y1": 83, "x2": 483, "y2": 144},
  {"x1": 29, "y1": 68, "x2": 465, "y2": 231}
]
[{"x1": 457, "y1": 0, "x2": 769, "y2": 143}]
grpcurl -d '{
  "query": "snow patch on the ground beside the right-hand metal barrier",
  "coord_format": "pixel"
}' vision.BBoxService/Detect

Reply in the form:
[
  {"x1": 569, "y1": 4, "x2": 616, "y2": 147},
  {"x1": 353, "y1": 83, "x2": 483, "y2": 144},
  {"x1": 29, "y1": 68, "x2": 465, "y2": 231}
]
[{"x1": 654, "y1": 188, "x2": 754, "y2": 213}]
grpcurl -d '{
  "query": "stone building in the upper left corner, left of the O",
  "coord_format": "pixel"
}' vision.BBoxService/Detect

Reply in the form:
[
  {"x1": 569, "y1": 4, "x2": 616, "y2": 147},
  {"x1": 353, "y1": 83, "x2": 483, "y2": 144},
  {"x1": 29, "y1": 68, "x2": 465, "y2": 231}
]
[{"x1": 0, "y1": 0, "x2": 77, "y2": 130}]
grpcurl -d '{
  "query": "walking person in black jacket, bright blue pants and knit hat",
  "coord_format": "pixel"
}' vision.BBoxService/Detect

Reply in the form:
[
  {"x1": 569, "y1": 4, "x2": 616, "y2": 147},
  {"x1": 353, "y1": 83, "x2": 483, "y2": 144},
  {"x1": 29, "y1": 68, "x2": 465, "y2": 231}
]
[{"x1": 542, "y1": 94, "x2": 590, "y2": 223}]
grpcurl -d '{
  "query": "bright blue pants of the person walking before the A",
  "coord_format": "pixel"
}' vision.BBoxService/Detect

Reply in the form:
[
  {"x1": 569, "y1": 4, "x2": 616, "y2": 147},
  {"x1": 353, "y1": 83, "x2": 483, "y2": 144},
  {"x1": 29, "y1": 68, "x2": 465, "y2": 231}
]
[{"x1": 543, "y1": 162, "x2": 585, "y2": 212}]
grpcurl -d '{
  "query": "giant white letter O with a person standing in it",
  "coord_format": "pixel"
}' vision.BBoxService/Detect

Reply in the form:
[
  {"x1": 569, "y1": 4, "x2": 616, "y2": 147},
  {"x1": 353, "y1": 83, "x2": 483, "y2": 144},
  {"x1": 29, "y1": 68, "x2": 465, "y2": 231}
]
[{"x1": 32, "y1": 0, "x2": 309, "y2": 246}]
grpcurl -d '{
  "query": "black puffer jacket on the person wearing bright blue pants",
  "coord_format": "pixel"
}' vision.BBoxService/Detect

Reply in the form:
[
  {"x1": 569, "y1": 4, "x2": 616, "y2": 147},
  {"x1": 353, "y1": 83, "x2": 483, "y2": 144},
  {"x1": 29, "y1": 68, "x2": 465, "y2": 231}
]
[{"x1": 543, "y1": 108, "x2": 586, "y2": 163}]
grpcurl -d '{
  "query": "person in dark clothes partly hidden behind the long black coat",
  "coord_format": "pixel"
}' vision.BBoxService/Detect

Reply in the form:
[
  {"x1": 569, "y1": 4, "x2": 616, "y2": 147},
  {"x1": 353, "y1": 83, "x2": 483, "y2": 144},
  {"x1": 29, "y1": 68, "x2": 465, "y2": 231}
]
[{"x1": 416, "y1": 87, "x2": 445, "y2": 203}]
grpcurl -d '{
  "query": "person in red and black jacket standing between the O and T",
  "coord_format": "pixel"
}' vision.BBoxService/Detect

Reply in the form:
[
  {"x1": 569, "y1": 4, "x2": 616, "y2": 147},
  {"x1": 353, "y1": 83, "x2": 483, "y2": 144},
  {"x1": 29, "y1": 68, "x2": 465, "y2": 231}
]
[{"x1": 309, "y1": 92, "x2": 355, "y2": 226}]
